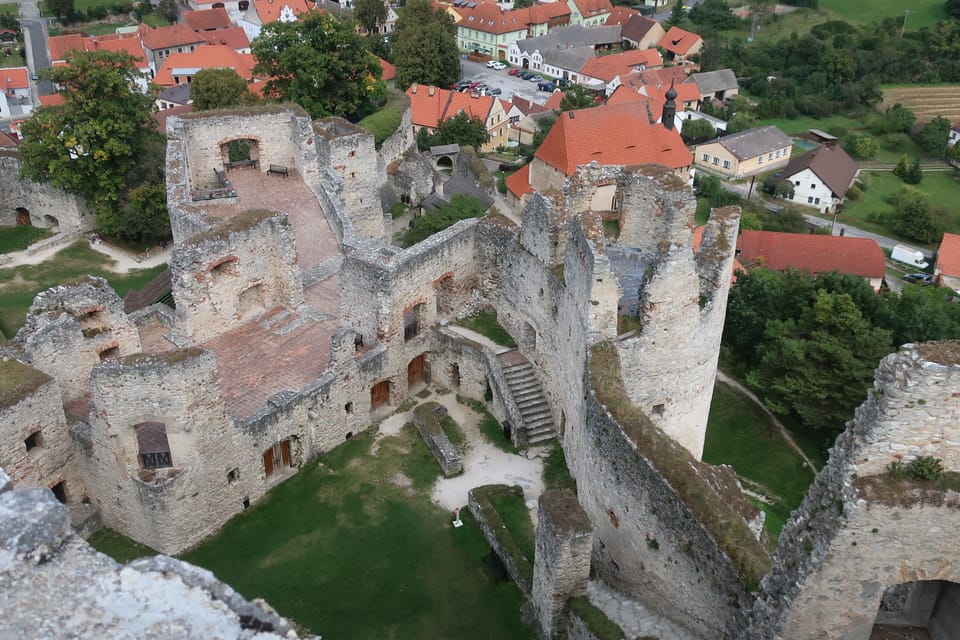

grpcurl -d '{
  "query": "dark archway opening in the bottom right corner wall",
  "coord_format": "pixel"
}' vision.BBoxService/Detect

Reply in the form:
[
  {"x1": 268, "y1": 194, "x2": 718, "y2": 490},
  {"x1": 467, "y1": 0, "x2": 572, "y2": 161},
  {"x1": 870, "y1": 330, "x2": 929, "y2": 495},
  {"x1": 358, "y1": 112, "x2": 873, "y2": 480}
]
[{"x1": 870, "y1": 580, "x2": 960, "y2": 640}]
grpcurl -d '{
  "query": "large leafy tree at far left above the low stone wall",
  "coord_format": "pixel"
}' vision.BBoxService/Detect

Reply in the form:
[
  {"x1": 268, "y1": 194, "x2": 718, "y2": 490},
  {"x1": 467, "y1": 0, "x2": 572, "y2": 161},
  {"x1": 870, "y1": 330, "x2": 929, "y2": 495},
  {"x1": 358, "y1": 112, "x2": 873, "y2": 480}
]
[{"x1": 20, "y1": 50, "x2": 154, "y2": 215}]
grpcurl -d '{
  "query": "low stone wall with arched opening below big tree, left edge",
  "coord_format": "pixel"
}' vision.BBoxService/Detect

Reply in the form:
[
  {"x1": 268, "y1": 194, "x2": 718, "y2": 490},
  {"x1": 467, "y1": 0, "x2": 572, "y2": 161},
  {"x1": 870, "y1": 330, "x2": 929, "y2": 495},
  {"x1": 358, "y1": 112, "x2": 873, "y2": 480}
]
[{"x1": 0, "y1": 152, "x2": 94, "y2": 235}]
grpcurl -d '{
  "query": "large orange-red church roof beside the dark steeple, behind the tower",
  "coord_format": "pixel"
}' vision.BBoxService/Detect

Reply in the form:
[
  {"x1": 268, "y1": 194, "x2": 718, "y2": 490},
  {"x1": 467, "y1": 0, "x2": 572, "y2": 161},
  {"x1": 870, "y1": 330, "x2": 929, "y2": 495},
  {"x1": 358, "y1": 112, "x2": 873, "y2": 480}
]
[{"x1": 536, "y1": 104, "x2": 693, "y2": 176}]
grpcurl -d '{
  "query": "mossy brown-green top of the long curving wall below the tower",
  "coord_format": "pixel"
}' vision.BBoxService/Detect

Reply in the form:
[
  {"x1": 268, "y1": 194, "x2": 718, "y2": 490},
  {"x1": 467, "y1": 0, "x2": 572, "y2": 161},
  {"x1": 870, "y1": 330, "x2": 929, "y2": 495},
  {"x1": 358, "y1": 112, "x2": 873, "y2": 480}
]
[{"x1": 589, "y1": 343, "x2": 770, "y2": 590}]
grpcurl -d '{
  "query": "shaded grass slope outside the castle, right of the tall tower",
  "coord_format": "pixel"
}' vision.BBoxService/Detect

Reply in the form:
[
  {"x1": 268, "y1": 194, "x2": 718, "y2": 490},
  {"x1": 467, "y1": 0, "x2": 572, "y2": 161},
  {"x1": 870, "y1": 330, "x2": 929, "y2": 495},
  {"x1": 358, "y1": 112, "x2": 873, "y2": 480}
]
[{"x1": 703, "y1": 383, "x2": 814, "y2": 543}]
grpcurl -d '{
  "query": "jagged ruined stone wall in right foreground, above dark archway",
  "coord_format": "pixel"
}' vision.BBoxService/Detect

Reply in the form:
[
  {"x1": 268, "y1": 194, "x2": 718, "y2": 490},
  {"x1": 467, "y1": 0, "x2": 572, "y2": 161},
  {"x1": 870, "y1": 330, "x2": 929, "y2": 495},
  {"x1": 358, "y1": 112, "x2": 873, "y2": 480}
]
[{"x1": 748, "y1": 343, "x2": 960, "y2": 640}]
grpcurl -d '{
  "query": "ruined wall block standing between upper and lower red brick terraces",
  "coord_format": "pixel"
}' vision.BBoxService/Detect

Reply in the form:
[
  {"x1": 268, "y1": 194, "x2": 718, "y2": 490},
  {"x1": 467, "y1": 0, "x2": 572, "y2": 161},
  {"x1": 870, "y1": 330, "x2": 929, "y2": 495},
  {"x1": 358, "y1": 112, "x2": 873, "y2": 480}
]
[{"x1": 169, "y1": 211, "x2": 303, "y2": 342}]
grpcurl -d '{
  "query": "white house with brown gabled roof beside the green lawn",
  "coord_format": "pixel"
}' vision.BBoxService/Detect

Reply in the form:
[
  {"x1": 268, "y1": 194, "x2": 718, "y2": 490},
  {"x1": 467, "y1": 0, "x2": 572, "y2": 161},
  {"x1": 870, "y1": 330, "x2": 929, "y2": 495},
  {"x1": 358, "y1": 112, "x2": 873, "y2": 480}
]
[{"x1": 783, "y1": 145, "x2": 860, "y2": 213}]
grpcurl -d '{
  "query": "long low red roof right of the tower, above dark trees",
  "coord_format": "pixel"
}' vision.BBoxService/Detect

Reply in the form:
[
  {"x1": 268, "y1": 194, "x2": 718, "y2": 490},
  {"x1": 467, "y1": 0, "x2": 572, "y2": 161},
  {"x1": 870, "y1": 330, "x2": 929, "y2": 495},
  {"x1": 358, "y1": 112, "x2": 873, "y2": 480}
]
[{"x1": 737, "y1": 230, "x2": 886, "y2": 278}]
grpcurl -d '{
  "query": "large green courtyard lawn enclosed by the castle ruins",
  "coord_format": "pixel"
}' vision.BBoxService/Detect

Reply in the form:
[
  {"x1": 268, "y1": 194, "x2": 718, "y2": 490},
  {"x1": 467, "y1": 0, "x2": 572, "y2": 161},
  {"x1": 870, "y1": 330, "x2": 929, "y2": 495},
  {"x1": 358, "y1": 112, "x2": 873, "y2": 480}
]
[{"x1": 183, "y1": 425, "x2": 535, "y2": 640}]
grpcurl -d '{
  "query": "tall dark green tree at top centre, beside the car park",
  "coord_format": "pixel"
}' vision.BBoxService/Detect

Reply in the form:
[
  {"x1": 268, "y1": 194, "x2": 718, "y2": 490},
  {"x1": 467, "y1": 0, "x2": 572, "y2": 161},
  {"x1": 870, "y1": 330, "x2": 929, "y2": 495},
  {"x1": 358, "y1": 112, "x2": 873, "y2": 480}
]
[{"x1": 393, "y1": 0, "x2": 460, "y2": 89}]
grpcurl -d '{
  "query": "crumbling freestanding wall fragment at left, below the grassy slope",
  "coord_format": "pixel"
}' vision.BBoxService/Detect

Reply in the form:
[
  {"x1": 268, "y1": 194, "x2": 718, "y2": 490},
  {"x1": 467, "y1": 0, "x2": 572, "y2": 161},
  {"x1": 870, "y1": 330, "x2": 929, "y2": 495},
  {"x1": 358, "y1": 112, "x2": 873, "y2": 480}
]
[{"x1": 8, "y1": 276, "x2": 140, "y2": 401}]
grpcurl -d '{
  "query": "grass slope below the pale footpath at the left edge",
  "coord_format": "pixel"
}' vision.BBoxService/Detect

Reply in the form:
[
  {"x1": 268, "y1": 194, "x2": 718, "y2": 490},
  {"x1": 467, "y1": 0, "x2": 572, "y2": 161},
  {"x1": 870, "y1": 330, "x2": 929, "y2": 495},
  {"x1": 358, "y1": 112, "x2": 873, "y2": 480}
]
[{"x1": 0, "y1": 240, "x2": 166, "y2": 337}]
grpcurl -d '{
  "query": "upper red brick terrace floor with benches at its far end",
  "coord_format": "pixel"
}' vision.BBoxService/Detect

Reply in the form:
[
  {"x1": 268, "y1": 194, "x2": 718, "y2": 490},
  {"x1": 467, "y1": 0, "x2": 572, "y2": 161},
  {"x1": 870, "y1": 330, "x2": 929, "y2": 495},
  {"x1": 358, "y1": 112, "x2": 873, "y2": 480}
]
[{"x1": 203, "y1": 168, "x2": 340, "y2": 271}]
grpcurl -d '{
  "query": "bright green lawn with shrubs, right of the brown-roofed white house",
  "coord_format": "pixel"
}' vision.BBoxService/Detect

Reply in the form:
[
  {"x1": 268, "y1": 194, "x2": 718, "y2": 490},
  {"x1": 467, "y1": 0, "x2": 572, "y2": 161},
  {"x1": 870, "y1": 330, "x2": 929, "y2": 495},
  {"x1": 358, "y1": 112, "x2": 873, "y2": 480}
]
[{"x1": 837, "y1": 171, "x2": 960, "y2": 246}]
